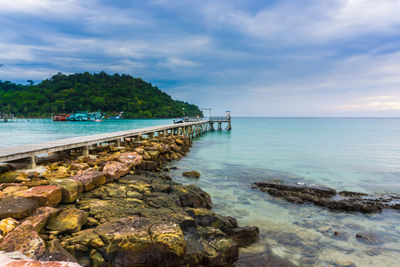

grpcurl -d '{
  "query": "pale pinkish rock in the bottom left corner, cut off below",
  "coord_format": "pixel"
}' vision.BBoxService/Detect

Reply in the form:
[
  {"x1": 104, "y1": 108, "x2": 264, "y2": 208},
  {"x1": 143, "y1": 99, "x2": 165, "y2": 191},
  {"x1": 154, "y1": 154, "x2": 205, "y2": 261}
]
[{"x1": 0, "y1": 252, "x2": 81, "y2": 267}]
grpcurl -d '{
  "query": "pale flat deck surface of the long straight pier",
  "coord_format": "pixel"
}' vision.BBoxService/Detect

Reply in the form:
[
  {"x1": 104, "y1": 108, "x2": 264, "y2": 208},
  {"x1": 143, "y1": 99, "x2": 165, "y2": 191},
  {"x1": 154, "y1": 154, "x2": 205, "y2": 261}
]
[{"x1": 0, "y1": 121, "x2": 208, "y2": 162}]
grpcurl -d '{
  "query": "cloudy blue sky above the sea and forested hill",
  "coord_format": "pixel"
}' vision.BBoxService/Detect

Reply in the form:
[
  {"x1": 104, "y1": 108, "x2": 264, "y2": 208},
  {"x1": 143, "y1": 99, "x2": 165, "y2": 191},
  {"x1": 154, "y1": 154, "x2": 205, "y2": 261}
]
[{"x1": 0, "y1": 0, "x2": 400, "y2": 117}]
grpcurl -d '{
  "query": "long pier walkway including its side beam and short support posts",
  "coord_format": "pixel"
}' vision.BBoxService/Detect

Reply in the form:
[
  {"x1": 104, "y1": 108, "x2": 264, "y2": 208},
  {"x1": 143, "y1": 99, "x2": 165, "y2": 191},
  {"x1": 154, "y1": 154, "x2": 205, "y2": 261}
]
[{"x1": 0, "y1": 120, "x2": 209, "y2": 168}]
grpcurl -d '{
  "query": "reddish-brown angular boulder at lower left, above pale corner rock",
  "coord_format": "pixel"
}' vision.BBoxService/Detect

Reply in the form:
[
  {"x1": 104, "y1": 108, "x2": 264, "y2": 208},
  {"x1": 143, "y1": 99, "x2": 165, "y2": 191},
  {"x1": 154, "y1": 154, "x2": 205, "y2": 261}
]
[{"x1": 0, "y1": 224, "x2": 46, "y2": 258}]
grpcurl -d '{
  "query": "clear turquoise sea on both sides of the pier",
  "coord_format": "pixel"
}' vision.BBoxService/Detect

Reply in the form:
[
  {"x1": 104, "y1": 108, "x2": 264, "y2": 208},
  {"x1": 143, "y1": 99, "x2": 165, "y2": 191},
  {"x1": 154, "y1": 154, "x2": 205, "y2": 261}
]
[{"x1": 0, "y1": 117, "x2": 400, "y2": 266}]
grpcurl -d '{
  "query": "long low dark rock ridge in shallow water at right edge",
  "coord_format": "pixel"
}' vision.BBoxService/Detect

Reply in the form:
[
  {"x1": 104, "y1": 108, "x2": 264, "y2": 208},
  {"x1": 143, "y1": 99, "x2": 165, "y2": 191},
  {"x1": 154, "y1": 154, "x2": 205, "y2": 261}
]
[{"x1": 253, "y1": 180, "x2": 400, "y2": 213}]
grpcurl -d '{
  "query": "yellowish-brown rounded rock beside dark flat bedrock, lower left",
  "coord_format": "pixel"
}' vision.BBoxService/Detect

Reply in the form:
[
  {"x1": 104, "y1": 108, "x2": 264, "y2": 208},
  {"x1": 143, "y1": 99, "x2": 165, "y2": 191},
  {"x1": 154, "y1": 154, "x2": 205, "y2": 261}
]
[{"x1": 46, "y1": 208, "x2": 88, "y2": 234}]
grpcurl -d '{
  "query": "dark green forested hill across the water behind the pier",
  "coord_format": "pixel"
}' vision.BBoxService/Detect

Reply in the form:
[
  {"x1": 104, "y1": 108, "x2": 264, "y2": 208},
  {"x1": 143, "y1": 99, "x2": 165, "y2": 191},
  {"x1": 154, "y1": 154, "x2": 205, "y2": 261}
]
[{"x1": 0, "y1": 72, "x2": 201, "y2": 118}]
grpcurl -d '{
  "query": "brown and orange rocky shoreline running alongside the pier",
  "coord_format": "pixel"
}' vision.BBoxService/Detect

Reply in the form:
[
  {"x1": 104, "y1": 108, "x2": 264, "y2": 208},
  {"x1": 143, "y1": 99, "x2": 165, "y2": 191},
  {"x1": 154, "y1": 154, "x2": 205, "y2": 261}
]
[{"x1": 0, "y1": 136, "x2": 260, "y2": 266}]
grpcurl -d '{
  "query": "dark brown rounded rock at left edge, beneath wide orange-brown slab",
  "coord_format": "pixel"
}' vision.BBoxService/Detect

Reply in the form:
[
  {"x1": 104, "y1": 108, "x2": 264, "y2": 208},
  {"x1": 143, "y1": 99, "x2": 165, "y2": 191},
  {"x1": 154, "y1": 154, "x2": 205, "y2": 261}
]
[{"x1": 0, "y1": 197, "x2": 38, "y2": 220}]
